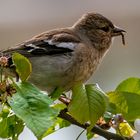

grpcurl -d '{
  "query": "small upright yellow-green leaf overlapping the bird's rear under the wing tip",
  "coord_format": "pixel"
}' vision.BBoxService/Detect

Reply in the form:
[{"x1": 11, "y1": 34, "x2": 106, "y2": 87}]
[{"x1": 12, "y1": 53, "x2": 32, "y2": 81}]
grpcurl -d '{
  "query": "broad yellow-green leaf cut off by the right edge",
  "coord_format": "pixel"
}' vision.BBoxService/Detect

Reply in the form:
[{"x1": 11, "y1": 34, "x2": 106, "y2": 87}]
[{"x1": 108, "y1": 78, "x2": 140, "y2": 121}]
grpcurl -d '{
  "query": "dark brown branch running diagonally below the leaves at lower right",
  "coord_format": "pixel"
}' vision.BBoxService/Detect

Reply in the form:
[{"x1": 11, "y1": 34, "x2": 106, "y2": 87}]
[{"x1": 58, "y1": 109, "x2": 133, "y2": 140}]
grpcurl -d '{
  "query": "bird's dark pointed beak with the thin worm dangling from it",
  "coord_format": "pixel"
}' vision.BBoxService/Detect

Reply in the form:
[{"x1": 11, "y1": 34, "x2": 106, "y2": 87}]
[{"x1": 111, "y1": 27, "x2": 126, "y2": 45}]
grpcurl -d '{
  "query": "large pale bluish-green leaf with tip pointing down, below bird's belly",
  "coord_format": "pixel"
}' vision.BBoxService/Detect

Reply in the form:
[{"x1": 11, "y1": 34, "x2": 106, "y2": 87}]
[{"x1": 9, "y1": 82, "x2": 59, "y2": 139}]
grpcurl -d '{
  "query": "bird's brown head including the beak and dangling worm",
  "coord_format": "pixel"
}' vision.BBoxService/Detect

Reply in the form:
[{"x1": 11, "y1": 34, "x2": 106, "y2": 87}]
[{"x1": 74, "y1": 13, "x2": 125, "y2": 49}]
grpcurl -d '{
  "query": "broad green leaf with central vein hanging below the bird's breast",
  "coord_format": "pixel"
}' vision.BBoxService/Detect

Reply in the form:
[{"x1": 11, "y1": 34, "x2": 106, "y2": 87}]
[{"x1": 68, "y1": 84, "x2": 107, "y2": 128}]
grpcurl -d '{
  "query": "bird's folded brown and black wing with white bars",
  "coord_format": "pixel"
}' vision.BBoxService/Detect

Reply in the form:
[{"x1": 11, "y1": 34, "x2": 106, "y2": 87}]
[{"x1": 5, "y1": 32, "x2": 80, "y2": 57}]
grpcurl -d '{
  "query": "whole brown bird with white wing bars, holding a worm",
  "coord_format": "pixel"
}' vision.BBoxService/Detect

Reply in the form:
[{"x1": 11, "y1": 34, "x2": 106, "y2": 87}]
[{"x1": 0, "y1": 12, "x2": 125, "y2": 93}]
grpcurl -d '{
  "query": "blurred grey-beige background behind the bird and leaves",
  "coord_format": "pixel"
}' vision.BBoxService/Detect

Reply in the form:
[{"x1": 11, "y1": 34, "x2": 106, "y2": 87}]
[{"x1": 0, "y1": 0, "x2": 140, "y2": 140}]
